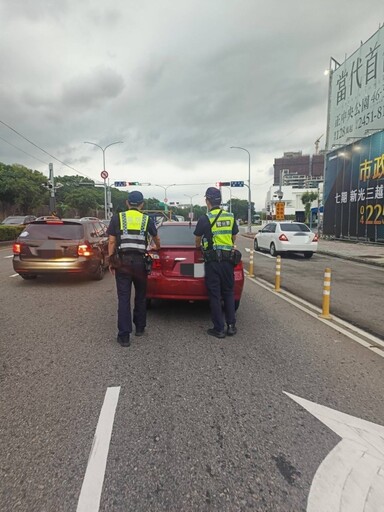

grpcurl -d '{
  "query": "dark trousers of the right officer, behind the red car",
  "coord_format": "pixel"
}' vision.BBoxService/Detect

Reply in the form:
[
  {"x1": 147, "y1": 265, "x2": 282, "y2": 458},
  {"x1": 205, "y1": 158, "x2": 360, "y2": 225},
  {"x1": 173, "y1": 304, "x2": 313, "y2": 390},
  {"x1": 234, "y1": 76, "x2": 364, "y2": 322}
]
[{"x1": 205, "y1": 261, "x2": 236, "y2": 331}]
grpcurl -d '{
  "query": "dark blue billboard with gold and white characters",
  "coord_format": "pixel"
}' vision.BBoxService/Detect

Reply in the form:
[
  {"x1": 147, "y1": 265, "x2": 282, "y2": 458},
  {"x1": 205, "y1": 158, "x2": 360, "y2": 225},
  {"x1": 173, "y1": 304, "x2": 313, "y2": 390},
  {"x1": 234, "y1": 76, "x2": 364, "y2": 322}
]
[{"x1": 323, "y1": 131, "x2": 384, "y2": 242}]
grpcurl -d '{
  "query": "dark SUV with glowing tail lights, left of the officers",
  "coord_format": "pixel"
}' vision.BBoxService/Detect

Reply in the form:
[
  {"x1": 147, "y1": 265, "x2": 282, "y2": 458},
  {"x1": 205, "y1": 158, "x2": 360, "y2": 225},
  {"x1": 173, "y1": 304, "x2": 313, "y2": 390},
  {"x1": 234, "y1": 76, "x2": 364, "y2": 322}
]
[{"x1": 13, "y1": 217, "x2": 109, "y2": 280}]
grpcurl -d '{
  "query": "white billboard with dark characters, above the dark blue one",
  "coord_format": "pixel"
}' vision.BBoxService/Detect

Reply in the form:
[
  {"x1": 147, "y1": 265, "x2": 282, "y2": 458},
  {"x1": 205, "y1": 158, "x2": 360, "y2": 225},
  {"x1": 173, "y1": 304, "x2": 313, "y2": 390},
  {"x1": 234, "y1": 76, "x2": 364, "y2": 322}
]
[{"x1": 326, "y1": 25, "x2": 384, "y2": 149}]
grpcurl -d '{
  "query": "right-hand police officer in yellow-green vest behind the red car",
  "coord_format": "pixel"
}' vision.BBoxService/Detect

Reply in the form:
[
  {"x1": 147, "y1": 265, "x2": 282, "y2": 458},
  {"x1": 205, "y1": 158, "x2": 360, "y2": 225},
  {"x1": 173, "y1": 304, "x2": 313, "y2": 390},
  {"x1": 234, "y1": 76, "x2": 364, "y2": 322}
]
[{"x1": 194, "y1": 187, "x2": 239, "y2": 338}]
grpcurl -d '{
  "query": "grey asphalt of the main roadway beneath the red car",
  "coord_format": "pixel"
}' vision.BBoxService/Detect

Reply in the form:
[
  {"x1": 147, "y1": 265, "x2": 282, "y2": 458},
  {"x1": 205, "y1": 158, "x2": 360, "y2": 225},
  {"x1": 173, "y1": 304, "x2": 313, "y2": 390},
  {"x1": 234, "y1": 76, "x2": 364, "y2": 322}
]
[{"x1": 0, "y1": 249, "x2": 384, "y2": 512}]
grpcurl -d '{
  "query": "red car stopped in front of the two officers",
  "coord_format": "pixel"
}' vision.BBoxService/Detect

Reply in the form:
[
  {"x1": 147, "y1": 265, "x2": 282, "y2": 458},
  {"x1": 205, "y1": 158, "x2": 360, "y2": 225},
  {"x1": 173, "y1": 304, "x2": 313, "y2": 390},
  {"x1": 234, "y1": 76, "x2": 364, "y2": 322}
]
[{"x1": 147, "y1": 222, "x2": 244, "y2": 309}]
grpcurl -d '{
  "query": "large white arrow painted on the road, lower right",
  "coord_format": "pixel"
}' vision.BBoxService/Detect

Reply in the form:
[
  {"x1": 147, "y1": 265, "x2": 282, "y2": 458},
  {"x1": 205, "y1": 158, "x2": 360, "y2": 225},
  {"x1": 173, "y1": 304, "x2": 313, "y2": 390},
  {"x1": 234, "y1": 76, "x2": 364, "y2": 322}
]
[{"x1": 284, "y1": 392, "x2": 384, "y2": 512}]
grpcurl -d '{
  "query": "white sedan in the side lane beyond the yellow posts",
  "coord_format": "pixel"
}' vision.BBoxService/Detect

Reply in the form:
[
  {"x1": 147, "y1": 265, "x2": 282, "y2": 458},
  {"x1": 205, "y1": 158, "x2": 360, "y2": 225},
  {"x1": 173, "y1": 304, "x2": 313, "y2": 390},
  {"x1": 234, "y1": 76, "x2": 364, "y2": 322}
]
[{"x1": 254, "y1": 221, "x2": 318, "y2": 258}]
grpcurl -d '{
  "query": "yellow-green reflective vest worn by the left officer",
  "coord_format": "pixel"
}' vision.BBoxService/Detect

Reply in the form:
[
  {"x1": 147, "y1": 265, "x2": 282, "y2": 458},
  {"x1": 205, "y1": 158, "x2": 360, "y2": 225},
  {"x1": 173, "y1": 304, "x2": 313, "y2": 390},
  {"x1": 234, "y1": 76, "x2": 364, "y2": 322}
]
[{"x1": 118, "y1": 210, "x2": 149, "y2": 254}]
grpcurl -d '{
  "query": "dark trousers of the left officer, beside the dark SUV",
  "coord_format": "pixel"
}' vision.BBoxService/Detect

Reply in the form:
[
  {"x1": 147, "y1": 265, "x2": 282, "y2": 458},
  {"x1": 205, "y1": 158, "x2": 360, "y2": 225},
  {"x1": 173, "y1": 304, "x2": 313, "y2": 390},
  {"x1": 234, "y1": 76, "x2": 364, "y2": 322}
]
[{"x1": 115, "y1": 254, "x2": 147, "y2": 336}]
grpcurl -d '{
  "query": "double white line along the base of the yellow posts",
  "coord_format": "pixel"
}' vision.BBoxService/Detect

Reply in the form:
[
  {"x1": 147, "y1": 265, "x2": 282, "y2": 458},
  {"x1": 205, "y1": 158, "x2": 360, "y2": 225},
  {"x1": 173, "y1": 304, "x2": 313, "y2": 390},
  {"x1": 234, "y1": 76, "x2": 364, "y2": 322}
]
[{"x1": 244, "y1": 276, "x2": 384, "y2": 357}]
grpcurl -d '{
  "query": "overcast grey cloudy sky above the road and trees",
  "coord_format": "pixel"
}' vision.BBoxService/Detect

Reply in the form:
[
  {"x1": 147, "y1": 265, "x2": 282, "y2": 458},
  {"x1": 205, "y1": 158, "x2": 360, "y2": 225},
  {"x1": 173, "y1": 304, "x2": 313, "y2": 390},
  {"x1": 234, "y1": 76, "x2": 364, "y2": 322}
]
[{"x1": 0, "y1": 0, "x2": 384, "y2": 208}]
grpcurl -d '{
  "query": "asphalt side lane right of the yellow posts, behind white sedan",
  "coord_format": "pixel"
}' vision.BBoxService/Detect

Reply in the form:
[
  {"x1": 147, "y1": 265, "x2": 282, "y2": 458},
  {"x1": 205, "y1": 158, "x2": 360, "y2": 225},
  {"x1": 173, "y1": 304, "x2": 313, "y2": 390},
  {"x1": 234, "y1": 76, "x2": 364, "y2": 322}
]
[{"x1": 237, "y1": 236, "x2": 384, "y2": 339}]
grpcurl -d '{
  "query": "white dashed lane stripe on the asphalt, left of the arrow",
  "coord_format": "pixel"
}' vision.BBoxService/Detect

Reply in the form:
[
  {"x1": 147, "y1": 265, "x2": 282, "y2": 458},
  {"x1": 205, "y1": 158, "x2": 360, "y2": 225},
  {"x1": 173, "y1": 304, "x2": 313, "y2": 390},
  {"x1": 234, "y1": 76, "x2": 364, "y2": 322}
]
[{"x1": 76, "y1": 386, "x2": 120, "y2": 512}]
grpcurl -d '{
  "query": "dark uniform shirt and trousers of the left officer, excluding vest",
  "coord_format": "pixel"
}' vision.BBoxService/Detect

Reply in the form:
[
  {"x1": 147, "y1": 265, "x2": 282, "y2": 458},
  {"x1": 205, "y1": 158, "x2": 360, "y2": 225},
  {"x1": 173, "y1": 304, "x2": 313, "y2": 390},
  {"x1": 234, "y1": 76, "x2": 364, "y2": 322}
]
[{"x1": 108, "y1": 208, "x2": 157, "y2": 338}]
